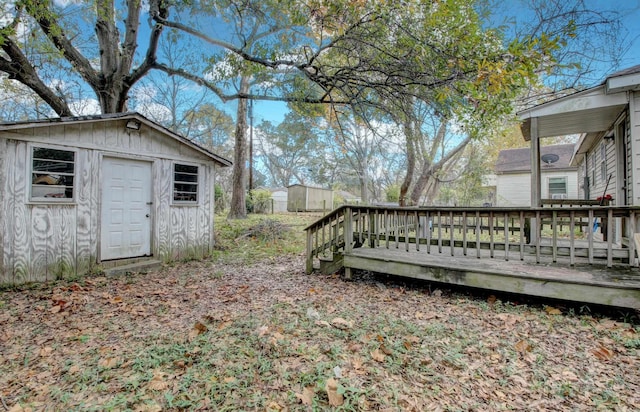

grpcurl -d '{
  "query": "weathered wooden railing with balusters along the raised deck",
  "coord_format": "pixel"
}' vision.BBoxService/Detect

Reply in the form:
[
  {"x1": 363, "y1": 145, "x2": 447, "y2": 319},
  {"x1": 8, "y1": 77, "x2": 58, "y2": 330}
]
[{"x1": 305, "y1": 205, "x2": 640, "y2": 273}]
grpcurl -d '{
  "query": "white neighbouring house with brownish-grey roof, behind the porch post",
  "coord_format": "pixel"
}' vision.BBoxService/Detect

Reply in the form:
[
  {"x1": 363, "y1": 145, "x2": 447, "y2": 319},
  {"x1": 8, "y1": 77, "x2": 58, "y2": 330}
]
[{"x1": 495, "y1": 144, "x2": 578, "y2": 206}]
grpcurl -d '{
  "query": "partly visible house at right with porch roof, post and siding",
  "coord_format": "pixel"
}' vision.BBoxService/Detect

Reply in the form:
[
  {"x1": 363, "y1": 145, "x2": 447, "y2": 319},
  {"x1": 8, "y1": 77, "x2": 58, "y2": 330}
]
[{"x1": 519, "y1": 65, "x2": 640, "y2": 242}]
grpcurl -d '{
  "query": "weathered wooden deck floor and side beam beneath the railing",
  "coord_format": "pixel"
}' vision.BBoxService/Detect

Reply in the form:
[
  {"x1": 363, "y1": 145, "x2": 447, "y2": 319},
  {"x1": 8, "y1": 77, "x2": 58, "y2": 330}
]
[{"x1": 344, "y1": 247, "x2": 640, "y2": 309}]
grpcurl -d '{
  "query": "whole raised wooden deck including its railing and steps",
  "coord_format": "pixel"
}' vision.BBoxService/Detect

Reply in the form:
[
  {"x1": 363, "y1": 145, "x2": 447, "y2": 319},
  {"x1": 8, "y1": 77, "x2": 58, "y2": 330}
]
[{"x1": 306, "y1": 206, "x2": 640, "y2": 309}]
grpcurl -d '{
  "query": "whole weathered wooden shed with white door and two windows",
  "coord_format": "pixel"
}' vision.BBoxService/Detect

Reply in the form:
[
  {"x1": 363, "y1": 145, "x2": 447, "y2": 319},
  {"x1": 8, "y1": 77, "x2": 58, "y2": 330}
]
[{"x1": 0, "y1": 113, "x2": 231, "y2": 284}]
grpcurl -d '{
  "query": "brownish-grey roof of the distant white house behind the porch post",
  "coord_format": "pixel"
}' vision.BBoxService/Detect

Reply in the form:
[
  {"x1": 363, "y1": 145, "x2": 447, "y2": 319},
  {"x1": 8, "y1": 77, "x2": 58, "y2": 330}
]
[{"x1": 495, "y1": 144, "x2": 575, "y2": 174}]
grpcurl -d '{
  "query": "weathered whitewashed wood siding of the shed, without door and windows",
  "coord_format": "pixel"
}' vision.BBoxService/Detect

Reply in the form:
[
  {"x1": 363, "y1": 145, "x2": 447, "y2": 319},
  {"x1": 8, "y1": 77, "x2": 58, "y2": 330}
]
[{"x1": 0, "y1": 120, "x2": 220, "y2": 284}]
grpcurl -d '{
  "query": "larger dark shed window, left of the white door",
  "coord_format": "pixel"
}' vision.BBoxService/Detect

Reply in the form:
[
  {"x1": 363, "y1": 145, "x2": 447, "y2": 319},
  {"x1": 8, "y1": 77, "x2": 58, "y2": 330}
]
[{"x1": 31, "y1": 147, "x2": 76, "y2": 202}]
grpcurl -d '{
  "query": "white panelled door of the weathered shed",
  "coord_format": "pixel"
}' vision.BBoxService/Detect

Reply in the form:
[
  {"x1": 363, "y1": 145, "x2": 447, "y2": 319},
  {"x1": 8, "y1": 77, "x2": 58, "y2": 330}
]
[{"x1": 100, "y1": 157, "x2": 151, "y2": 260}]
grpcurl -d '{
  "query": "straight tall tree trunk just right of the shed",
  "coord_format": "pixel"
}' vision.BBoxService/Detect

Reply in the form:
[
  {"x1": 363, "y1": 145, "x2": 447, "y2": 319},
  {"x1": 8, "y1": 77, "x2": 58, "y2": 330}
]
[{"x1": 227, "y1": 76, "x2": 250, "y2": 219}]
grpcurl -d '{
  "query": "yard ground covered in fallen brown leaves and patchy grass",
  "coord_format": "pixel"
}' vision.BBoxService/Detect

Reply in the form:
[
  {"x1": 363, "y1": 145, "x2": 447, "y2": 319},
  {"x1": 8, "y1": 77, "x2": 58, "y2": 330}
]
[{"x1": 0, "y1": 214, "x2": 640, "y2": 411}]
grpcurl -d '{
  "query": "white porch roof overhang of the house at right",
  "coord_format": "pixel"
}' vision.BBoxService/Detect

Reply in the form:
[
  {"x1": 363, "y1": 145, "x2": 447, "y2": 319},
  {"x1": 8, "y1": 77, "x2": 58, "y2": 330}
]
[{"x1": 518, "y1": 84, "x2": 629, "y2": 141}]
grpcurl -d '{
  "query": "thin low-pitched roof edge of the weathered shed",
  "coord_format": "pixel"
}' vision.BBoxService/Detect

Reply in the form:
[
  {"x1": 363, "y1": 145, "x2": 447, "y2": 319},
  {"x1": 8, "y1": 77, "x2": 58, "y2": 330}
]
[{"x1": 0, "y1": 112, "x2": 233, "y2": 166}]
